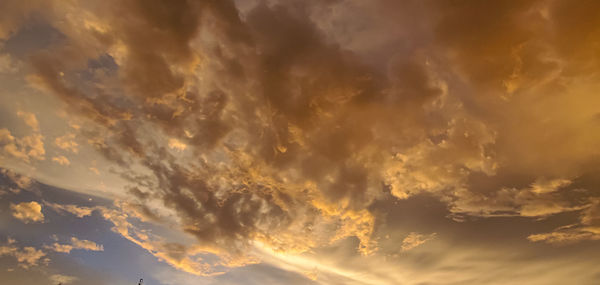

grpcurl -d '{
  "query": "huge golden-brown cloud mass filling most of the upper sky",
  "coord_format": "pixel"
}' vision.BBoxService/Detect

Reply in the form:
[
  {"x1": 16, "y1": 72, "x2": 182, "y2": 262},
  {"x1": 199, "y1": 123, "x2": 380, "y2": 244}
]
[{"x1": 0, "y1": 0, "x2": 600, "y2": 274}]
